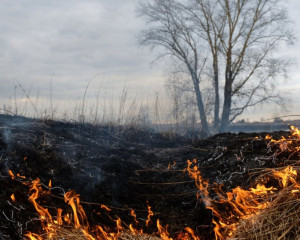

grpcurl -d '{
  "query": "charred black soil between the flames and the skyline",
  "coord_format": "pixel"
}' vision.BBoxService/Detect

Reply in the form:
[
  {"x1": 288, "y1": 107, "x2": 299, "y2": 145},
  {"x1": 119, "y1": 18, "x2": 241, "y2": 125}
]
[{"x1": 0, "y1": 115, "x2": 288, "y2": 240}]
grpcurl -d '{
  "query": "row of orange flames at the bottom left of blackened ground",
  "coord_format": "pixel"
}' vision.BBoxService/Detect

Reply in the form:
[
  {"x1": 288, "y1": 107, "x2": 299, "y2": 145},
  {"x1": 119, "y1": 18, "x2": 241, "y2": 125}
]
[{"x1": 22, "y1": 175, "x2": 185, "y2": 240}]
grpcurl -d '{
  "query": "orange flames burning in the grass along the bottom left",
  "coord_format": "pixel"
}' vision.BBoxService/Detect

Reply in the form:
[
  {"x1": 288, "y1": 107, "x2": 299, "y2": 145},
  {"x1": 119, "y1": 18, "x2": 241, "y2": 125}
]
[{"x1": 9, "y1": 171, "x2": 171, "y2": 240}]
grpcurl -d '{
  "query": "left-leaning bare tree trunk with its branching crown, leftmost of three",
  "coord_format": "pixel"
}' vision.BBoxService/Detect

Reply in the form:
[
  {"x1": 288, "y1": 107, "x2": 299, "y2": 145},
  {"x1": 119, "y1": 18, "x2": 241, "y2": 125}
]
[{"x1": 139, "y1": 0, "x2": 209, "y2": 135}]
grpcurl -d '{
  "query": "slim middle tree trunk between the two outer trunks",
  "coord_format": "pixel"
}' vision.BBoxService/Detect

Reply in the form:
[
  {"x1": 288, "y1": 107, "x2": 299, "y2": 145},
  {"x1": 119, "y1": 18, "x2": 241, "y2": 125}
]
[{"x1": 213, "y1": 55, "x2": 220, "y2": 131}]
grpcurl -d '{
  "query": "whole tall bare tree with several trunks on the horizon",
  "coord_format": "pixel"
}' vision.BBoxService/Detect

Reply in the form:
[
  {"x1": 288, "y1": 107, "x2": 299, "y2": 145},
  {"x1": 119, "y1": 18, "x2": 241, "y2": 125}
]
[{"x1": 140, "y1": 0, "x2": 293, "y2": 133}]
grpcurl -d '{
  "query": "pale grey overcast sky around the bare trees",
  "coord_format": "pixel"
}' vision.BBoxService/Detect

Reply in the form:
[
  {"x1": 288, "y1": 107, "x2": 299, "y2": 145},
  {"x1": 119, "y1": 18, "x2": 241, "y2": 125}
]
[{"x1": 0, "y1": 0, "x2": 300, "y2": 120}]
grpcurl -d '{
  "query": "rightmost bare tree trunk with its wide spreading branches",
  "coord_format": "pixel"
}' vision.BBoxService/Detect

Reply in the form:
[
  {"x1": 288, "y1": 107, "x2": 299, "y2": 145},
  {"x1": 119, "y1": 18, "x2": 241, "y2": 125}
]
[{"x1": 212, "y1": 0, "x2": 293, "y2": 131}]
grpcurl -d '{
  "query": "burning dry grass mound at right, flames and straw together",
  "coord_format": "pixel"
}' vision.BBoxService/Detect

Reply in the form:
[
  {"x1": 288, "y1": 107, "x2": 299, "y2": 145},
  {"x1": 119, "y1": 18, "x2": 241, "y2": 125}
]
[{"x1": 188, "y1": 126, "x2": 300, "y2": 239}]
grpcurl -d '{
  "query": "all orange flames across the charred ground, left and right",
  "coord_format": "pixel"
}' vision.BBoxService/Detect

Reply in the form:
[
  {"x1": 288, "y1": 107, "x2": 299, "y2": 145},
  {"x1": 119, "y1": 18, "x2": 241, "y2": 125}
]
[{"x1": 14, "y1": 126, "x2": 300, "y2": 240}]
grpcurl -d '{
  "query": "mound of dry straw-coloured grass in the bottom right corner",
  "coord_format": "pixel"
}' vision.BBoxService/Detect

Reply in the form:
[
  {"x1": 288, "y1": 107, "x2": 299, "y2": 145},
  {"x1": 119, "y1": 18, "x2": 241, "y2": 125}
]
[{"x1": 233, "y1": 186, "x2": 300, "y2": 240}]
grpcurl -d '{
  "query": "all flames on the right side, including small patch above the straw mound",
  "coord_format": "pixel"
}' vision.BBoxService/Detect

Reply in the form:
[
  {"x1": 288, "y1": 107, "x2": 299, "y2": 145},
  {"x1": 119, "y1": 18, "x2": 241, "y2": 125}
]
[{"x1": 187, "y1": 126, "x2": 300, "y2": 240}]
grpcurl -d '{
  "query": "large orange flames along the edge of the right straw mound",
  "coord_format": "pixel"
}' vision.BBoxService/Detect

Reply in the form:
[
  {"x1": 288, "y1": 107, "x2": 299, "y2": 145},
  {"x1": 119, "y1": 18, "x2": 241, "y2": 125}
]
[{"x1": 187, "y1": 160, "x2": 299, "y2": 239}]
